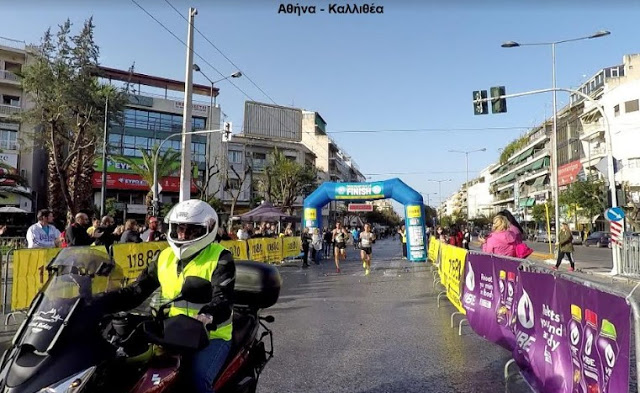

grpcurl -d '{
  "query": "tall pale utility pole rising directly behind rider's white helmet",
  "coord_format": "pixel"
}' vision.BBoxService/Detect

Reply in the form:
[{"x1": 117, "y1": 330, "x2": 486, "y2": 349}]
[{"x1": 180, "y1": 8, "x2": 198, "y2": 202}]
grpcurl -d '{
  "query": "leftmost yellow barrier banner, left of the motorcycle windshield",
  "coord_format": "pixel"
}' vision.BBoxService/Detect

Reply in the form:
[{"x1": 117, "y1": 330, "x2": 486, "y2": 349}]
[{"x1": 11, "y1": 248, "x2": 61, "y2": 310}]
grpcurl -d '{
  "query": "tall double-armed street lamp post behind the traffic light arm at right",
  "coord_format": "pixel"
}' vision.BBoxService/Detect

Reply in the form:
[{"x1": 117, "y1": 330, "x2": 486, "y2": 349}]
[{"x1": 501, "y1": 30, "x2": 616, "y2": 240}]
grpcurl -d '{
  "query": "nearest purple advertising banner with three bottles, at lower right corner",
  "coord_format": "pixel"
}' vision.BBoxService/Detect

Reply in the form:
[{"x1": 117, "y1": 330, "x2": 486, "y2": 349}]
[{"x1": 512, "y1": 271, "x2": 631, "y2": 393}]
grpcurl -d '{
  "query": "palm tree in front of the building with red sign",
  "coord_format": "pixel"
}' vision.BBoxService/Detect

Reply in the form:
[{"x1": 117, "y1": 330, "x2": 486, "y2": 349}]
[{"x1": 113, "y1": 145, "x2": 182, "y2": 208}]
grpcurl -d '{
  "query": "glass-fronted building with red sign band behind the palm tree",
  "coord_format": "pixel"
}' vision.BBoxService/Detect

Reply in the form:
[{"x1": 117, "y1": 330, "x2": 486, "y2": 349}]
[{"x1": 93, "y1": 67, "x2": 220, "y2": 218}]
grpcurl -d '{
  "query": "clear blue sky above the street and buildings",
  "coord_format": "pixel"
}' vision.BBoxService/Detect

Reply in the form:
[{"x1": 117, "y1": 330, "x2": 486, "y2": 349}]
[{"x1": 0, "y1": 0, "x2": 640, "y2": 214}]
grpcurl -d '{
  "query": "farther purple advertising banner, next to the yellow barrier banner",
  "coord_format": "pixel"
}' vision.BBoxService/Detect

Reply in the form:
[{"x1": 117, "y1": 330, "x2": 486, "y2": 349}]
[{"x1": 462, "y1": 252, "x2": 520, "y2": 351}]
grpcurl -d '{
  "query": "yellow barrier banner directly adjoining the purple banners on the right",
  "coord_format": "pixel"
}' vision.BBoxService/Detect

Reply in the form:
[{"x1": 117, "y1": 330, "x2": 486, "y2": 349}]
[{"x1": 440, "y1": 244, "x2": 467, "y2": 314}]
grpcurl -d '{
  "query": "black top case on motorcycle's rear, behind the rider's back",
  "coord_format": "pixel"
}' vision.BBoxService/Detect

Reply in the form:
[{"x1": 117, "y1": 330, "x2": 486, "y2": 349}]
[{"x1": 234, "y1": 261, "x2": 282, "y2": 308}]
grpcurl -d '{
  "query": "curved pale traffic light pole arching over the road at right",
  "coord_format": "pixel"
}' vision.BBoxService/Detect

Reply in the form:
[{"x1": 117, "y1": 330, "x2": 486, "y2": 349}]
[{"x1": 473, "y1": 87, "x2": 620, "y2": 275}]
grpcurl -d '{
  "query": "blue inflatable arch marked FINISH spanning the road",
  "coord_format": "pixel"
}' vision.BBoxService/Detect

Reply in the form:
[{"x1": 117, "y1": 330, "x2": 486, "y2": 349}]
[{"x1": 302, "y1": 178, "x2": 427, "y2": 262}]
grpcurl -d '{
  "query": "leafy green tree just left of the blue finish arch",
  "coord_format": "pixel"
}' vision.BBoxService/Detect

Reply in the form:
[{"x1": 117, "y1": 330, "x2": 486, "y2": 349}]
[{"x1": 263, "y1": 149, "x2": 318, "y2": 214}]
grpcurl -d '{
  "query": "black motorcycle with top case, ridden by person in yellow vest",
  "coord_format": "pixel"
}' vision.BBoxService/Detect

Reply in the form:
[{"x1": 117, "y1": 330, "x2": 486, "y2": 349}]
[{"x1": 0, "y1": 247, "x2": 281, "y2": 393}]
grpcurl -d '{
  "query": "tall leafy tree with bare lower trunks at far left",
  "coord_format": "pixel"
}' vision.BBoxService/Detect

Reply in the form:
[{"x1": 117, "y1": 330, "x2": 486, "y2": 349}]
[{"x1": 20, "y1": 18, "x2": 126, "y2": 220}]
